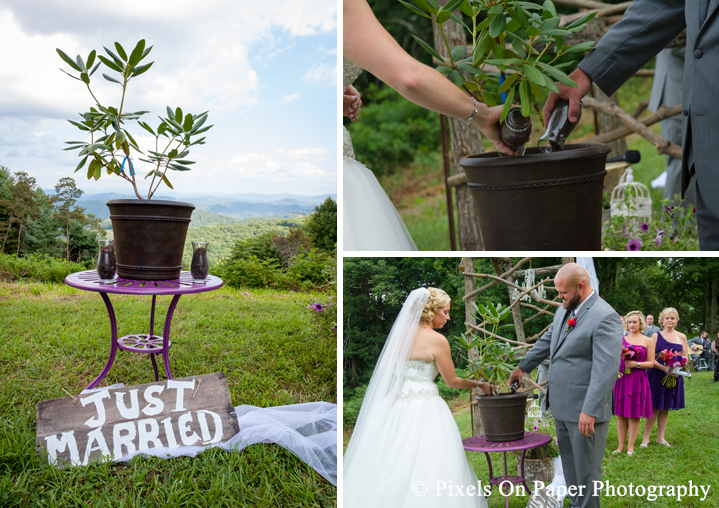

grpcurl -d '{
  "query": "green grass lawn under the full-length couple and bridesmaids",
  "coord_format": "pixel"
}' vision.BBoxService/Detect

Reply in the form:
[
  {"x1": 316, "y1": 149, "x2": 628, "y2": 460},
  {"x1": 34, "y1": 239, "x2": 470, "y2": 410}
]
[{"x1": 343, "y1": 372, "x2": 719, "y2": 508}]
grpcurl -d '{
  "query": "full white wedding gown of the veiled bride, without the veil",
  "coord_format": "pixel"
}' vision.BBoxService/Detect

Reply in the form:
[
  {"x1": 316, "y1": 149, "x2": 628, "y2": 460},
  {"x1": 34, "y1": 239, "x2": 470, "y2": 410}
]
[{"x1": 343, "y1": 360, "x2": 487, "y2": 508}]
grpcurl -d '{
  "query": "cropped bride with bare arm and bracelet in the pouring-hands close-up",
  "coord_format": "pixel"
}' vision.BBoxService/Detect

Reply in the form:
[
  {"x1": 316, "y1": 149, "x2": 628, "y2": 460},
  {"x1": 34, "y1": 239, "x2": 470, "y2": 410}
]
[{"x1": 342, "y1": 0, "x2": 511, "y2": 250}]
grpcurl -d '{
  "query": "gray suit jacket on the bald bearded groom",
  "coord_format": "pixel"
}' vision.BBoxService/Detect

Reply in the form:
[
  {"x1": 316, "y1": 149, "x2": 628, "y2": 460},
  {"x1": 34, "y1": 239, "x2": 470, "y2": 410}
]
[{"x1": 519, "y1": 291, "x2": 623, "y2": 422}]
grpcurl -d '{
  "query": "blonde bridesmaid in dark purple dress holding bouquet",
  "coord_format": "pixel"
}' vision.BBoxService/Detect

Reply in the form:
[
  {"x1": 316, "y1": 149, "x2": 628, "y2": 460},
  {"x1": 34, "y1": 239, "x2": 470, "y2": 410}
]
[{"x1": 640, "y1": 307, "x2": 689, "y2": 448}]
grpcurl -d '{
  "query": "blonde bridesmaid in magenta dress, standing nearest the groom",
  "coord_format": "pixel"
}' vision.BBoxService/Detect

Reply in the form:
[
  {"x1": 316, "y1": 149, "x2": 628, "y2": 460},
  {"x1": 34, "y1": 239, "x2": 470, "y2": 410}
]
[{"x1": 612, "y1": 310, "x2": 654, "y2": 457}]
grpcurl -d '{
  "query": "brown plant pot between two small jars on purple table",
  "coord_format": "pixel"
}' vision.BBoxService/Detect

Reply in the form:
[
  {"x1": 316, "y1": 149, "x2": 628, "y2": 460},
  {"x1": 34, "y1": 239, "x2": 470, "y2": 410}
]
[{"x1": 107, "y1": 199, "x2": 195, "y2": 280}]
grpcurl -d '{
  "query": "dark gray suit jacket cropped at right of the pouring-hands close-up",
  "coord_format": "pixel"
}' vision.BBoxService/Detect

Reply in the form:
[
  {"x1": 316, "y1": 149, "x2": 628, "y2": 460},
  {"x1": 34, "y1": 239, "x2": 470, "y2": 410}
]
[{"x1": 579, "y1": 0, "x2": 719, "y2": 216}]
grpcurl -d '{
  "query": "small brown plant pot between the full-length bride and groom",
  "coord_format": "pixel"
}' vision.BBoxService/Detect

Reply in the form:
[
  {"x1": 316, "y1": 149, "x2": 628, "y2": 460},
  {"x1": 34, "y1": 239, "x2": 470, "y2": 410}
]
[{"x1": 477, "y1": 393, "x2": 527, "y2": 442}]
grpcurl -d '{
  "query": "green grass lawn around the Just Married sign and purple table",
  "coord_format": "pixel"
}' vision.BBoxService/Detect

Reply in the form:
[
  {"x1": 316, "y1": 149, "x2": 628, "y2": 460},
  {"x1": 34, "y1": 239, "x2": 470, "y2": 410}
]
[{"x1": 0, "y1": 283, "x2": 337, "y2": 507}]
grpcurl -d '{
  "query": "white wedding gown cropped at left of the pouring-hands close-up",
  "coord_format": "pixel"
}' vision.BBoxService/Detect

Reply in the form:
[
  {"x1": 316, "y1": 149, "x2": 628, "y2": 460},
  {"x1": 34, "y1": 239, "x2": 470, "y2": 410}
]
[{"x1": 342, "y1": 58, "x2": 417, "y2": 251}]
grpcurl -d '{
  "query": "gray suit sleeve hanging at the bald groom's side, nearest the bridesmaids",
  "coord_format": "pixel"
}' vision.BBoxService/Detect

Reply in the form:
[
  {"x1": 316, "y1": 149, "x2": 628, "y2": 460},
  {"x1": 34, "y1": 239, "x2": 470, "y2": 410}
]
[{"x1": 582, "y1": 312, "x2": 623, "y2": 417}]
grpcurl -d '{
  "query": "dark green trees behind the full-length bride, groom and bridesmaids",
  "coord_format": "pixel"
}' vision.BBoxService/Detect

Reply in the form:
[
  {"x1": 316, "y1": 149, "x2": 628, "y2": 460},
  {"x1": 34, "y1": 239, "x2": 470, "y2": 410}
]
[{"x1": 343, "y1": 258, "x2": 719, "y2": 396}]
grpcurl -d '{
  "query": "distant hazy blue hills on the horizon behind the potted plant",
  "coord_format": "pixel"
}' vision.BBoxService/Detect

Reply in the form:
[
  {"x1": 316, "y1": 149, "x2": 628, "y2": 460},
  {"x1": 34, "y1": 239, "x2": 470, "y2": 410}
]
[{"x1": 67, "y1": 189, "x2": 337, "y2": 220}]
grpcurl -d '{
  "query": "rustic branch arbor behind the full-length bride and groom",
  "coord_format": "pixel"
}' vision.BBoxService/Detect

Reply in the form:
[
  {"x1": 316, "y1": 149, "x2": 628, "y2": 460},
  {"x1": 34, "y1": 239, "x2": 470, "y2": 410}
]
[{"x1": 459, "y1": 258, "x2": 574, "y2": 436}]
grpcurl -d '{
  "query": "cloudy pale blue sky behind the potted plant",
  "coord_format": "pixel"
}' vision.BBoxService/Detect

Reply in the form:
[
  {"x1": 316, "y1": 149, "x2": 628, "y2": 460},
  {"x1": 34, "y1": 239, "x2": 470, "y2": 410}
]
[{"x1": 0, "y1": 0, "x2": 338, "y2": 195}]
